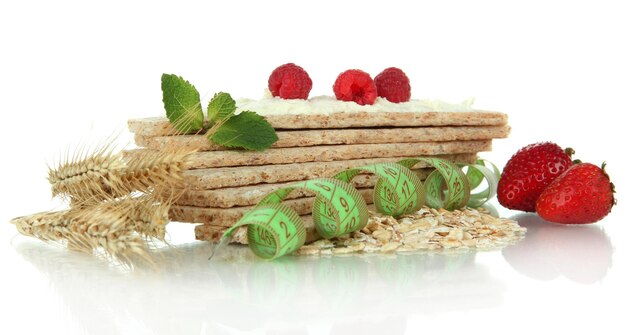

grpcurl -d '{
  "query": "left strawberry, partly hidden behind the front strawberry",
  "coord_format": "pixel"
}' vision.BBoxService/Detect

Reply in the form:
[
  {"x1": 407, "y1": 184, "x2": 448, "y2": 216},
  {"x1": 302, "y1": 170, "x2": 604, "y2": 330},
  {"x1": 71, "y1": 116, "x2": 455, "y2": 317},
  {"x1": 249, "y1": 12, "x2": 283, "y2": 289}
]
[{"x1": 498, "y1": 142, "x2": 573, "y2": 212}]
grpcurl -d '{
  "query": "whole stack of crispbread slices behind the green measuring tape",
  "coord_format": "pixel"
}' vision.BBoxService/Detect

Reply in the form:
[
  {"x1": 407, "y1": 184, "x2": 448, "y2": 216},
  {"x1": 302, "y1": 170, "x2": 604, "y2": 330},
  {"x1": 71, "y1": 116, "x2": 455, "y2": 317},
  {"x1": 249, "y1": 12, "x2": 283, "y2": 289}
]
[{"x1": 126, "y1": 111, "x2": 510, "y2": 243}]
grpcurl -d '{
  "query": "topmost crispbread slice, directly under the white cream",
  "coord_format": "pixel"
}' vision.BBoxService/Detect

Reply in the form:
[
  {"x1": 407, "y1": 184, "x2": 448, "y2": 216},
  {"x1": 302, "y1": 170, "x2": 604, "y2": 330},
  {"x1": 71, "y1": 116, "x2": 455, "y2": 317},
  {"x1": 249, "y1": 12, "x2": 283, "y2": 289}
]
[{"x1": 128, "y1": 110, "x2": 508, "y2": 136}]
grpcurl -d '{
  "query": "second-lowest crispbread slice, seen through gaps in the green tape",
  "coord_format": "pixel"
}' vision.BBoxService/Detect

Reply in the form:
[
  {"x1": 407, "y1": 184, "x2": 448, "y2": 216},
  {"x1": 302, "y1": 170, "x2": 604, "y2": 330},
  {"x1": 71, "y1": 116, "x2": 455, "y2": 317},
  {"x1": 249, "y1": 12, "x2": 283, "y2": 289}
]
[{"x1": 170, "y1": 188, "x2": 374, "y2": 227}]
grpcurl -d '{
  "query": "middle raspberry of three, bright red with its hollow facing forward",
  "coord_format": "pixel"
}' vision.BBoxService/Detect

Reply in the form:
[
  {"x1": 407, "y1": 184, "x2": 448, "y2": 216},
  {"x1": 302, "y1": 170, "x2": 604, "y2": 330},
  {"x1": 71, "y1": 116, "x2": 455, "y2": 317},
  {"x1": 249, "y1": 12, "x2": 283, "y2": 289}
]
[{"x1": 333, "y1": 70, "x2": 377, "y2": 105}]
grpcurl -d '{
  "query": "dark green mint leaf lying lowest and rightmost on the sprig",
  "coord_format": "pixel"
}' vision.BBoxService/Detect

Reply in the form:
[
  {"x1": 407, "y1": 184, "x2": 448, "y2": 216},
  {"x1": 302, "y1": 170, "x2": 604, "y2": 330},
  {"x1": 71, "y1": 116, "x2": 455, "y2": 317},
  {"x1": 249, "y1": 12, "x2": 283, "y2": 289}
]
[{"x1": 211, "y1": 111, "x2": 278, "y2": 151}]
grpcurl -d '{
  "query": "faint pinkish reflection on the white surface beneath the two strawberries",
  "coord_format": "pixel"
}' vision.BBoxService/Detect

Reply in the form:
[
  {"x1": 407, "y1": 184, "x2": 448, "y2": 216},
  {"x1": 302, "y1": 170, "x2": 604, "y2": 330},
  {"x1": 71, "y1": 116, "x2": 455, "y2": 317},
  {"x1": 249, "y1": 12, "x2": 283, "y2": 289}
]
[{"x1": 502, "y1": 214, "x2": 613, "y2": 284}]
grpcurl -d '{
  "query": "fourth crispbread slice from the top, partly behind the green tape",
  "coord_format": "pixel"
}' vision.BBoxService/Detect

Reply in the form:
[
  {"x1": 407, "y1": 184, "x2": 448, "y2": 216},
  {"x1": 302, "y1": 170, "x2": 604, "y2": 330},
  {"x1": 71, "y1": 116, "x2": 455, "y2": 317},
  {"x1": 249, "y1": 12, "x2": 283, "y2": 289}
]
[{"x1": 184, "y1": 152, "x2": 476, "y2": 190}]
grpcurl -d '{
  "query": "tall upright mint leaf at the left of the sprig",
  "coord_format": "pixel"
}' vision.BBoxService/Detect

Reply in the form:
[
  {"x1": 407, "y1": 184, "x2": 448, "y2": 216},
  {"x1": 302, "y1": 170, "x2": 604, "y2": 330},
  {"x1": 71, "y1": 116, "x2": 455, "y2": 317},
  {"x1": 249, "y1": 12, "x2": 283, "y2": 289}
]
[{"x1": 161, "y1": 73, "x2": 204, "y2": 133}]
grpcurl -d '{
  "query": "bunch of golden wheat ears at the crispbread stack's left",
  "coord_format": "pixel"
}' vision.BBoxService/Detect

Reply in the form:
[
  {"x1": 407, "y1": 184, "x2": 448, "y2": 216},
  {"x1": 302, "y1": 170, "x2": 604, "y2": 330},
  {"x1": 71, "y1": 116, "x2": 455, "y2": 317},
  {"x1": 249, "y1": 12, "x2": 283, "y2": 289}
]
[{"x1": 16, "y1": 119, "x2": 199, "y2": 265}]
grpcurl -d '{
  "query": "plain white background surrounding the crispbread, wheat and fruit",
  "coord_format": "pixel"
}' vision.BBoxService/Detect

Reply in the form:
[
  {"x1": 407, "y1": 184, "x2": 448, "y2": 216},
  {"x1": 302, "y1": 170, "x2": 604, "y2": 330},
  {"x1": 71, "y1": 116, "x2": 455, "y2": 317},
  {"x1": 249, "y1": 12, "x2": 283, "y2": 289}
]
[{"x1": 0, "y1": 0, "x2": 626, "y2": 334}]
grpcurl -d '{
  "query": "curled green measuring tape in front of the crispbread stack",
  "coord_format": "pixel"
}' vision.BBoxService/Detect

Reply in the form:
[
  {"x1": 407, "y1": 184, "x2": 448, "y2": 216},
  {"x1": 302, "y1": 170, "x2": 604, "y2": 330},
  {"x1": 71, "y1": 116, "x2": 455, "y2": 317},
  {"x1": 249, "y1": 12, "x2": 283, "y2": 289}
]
[{"x1": 213, "y1": 157, "x2": 500, "y2": 259}]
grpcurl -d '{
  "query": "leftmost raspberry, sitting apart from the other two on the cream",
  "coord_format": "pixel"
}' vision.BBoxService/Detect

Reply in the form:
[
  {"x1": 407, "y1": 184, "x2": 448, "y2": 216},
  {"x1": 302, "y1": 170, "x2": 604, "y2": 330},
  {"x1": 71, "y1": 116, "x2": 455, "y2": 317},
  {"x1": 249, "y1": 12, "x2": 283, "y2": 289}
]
[{"x1": 267, "y1": 63, "x2": 313, "y2": 99}]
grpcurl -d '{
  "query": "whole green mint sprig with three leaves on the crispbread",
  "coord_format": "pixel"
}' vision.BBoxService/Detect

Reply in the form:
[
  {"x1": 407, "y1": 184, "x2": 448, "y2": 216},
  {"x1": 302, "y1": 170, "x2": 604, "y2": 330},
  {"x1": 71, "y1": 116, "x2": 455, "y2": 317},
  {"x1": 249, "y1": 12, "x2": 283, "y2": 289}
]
[{"x1": 161, "y1": 74, "x2": 278, "y2": 151}]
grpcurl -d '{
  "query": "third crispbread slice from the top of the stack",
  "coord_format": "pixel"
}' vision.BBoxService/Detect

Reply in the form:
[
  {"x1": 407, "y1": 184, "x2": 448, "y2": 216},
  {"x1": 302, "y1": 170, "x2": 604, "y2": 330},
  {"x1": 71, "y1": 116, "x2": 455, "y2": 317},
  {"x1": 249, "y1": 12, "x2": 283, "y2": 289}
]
[{"x1": 125, "y1": 140, "x2": 491, "y2": 169}]
